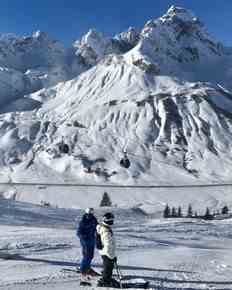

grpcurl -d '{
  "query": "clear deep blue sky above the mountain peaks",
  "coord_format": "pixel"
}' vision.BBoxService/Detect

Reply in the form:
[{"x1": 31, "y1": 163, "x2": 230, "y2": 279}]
[{"x1": 0, "y1": 0, "x2": 232, "y2": 46}]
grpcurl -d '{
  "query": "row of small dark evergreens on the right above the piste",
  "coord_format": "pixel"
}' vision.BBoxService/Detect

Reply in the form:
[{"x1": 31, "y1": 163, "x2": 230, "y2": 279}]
[{"x1": 163, "y1": 204, "x2": 229, "y2": 220}]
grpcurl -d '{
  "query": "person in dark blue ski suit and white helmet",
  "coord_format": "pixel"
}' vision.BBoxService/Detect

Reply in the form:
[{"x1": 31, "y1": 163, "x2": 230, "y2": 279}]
[{"x1": 77, "y1": 208, "x2": 98, "y2": 275}]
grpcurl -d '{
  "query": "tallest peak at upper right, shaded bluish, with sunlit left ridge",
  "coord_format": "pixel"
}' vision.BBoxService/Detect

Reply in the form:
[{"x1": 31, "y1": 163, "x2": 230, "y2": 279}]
[{"x1": 127, "y1": 6, "x2": 232, "y2": 87}]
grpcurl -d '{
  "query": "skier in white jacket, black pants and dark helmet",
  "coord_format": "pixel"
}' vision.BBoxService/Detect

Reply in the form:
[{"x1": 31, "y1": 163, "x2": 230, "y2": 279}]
[{"x1": 97, "y1": 212, "x2": 120, "y2": 287}]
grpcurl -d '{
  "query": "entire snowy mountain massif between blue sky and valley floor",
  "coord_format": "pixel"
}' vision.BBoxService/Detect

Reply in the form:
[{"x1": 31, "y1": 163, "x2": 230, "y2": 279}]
[{"x1": 0, "y1": 6, "x2": 232, "y2": 190}]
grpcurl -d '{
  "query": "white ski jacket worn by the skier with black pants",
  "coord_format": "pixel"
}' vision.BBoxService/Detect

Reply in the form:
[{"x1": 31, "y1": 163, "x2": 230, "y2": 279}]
[{"x1": 97, "y1": 223, "x2": 116, "y2": 259}]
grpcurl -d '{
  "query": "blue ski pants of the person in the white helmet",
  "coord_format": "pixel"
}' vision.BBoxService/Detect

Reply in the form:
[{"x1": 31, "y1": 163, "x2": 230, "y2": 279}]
[{"x1": 80, "y1": 239, "x2": 95, "y2": 273}]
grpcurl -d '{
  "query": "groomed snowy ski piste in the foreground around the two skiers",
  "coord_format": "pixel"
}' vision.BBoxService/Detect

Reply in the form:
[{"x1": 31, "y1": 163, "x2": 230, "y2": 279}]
[{"x1": 0, "y1": 202, "x2": 232, "y2": 290}]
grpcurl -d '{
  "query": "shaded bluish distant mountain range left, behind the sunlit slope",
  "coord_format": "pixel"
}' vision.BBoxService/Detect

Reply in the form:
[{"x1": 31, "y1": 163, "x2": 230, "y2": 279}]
[{"x1": 0, "y1": 28, "x2": 138, "y2": 111}]
